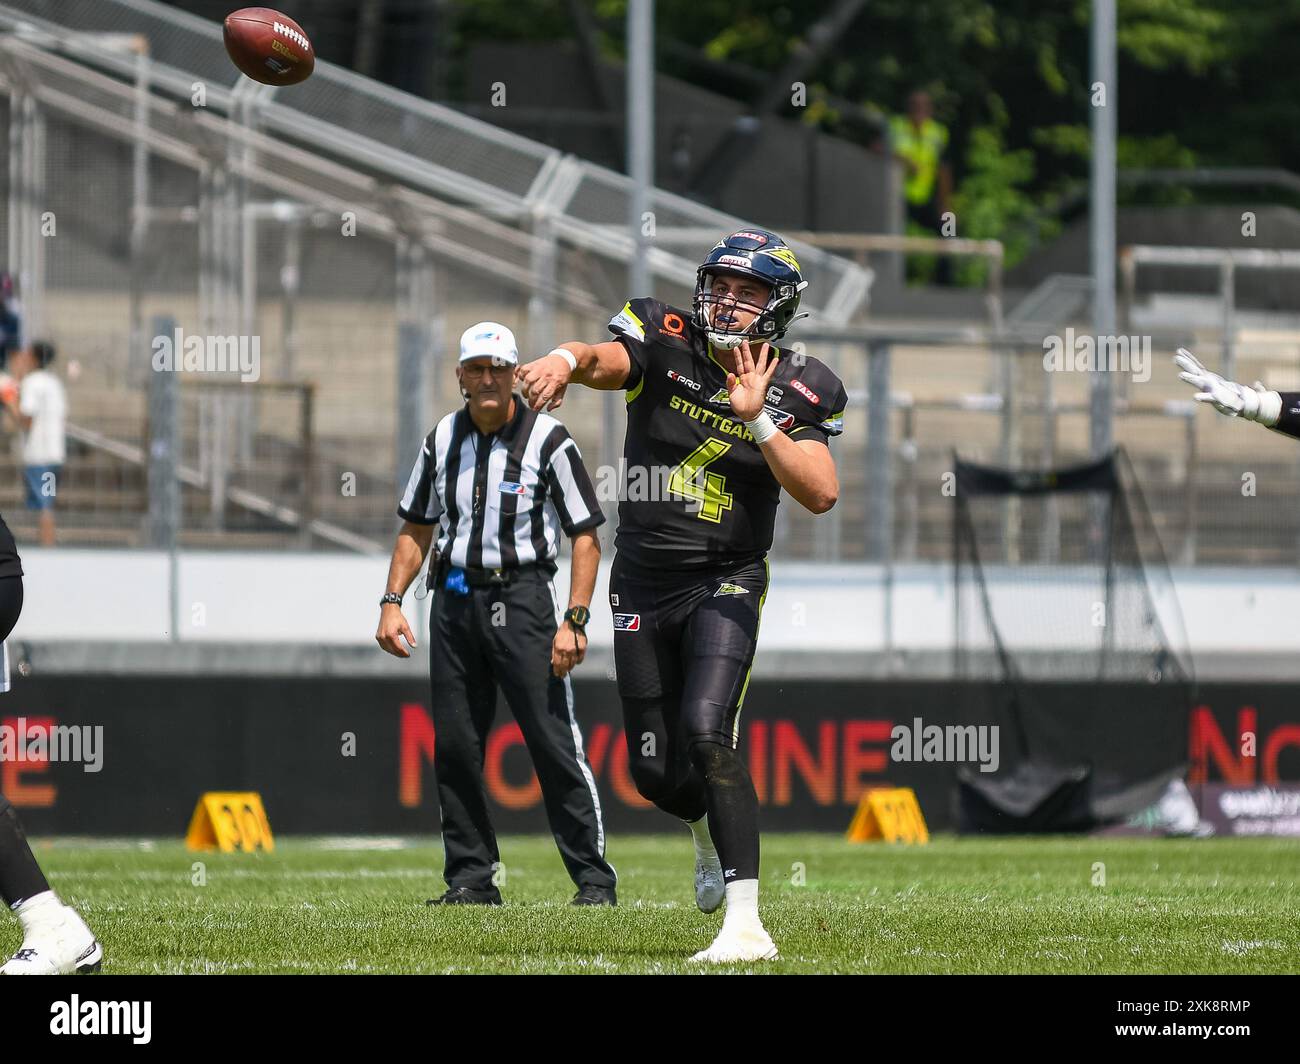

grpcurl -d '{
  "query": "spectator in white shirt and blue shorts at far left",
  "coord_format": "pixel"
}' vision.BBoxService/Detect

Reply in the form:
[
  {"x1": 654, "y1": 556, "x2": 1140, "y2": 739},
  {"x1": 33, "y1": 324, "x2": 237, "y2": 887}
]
[{"x1": 4, "y1": 339, "x2": 68, "y2": 546}]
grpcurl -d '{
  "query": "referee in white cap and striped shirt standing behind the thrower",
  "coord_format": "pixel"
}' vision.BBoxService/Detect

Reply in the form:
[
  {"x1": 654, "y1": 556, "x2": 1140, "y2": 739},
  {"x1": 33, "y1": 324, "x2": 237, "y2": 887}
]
[{"x1": 374, "y1": 321, "x2": 616, "y2": 905}]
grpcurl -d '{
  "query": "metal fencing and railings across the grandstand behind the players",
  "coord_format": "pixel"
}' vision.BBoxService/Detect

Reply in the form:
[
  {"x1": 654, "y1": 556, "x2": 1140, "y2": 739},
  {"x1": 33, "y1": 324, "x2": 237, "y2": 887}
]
[{"x1": 0, "y1": 0, "x2": 1300, "y2": 563}]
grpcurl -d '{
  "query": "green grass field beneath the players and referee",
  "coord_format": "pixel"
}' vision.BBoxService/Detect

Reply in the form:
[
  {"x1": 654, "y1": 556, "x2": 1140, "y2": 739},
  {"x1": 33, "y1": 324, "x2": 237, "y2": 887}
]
[{"x1": 10, "y1": 832, "x2": 1300, "y2": 973}]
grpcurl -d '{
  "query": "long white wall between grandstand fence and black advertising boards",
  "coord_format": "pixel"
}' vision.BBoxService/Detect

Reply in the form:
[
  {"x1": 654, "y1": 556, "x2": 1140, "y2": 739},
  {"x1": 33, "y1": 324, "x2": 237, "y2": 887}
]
[{"x1": 13, "y1": 548, "x2": 1300, "y2": 679}]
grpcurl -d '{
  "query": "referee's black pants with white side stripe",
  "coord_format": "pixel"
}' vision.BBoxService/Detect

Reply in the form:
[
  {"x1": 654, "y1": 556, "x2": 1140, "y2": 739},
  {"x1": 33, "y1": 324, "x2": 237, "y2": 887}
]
[{"x1": 429, "y1": 570, "x2": 615, "y2": 890}]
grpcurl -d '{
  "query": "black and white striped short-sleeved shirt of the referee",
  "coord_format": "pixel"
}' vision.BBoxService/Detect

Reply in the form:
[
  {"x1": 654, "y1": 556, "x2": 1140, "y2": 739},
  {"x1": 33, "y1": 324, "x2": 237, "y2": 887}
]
[{"x1": 398, "y1": 395, "x2": 605, "y2": 568}]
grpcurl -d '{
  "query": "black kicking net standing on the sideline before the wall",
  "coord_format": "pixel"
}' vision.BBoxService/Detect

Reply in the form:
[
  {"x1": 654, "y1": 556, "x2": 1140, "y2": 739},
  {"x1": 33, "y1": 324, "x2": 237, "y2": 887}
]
[{"x1": 953, "y1": 450, "x2": 1192, "y2": 830}]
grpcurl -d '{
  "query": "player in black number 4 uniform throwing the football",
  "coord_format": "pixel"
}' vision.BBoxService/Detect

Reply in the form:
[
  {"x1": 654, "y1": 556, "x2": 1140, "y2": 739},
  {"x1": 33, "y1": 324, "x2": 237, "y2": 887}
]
[{"x1": 520, "y1": 229, "x2": 845, "y2": 963}]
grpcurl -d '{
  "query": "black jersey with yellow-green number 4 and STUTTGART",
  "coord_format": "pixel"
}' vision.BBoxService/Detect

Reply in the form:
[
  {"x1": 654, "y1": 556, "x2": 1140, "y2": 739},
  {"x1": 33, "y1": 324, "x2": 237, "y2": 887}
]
[{"x1": 610, "y1": 299, "x2": 846, "y2": 568}]
